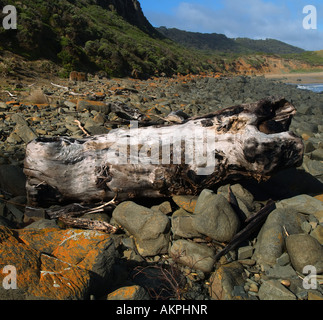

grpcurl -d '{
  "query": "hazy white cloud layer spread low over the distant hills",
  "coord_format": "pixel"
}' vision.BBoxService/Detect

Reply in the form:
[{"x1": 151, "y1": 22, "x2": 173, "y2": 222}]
[{"x1": 148, "y1": 0, "x2": 323, "y2": 50}]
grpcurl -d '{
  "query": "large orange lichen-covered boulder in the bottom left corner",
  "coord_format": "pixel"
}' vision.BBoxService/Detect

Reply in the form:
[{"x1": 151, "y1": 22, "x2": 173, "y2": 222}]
[{"x1": 0, "y1": 227, "x2": 116, "y2": 300}]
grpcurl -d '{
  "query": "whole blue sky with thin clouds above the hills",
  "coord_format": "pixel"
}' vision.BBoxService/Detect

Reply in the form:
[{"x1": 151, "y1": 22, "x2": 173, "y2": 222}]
[{"x1": 139, "y1": 0, "x2": 323, "y2": 50}]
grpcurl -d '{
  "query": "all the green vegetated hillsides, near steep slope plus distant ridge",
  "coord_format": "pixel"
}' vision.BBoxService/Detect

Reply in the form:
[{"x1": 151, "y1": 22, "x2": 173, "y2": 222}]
[{"x1": 0, "y1": 0, "x2": 323, "y2": 77}]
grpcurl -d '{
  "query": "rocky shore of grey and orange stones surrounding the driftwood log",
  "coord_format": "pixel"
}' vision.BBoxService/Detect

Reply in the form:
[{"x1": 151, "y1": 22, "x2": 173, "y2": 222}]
[{"x1": 0, "y1": 75, "x2": 323, "y2": 300}]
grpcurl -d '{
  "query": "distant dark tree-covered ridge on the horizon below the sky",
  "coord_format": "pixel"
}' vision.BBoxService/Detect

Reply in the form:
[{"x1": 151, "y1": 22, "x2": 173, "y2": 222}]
[{"x1": 157, "y1": 27, "x2": 304, "y2": 54}]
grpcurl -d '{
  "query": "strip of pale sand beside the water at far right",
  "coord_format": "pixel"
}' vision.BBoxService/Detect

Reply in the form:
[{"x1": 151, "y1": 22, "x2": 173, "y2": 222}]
[{"x1": 265, "y1": 71, "x2": 323, "y2": 84}]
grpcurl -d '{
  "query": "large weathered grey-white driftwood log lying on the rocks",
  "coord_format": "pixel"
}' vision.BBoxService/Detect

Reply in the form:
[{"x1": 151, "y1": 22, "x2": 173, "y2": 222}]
[{"x1": 24, "y1": 98, "x2": 304, "y2": 207}]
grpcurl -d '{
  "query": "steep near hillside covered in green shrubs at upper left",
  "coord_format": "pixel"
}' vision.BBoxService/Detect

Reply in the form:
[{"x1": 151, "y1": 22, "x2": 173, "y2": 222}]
[{"x1": 0, "y1": 0, "x2": 220, "y2": 76}]
